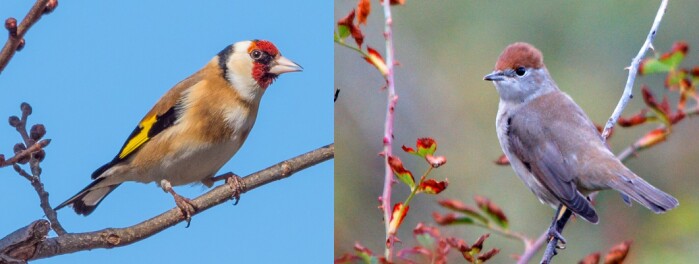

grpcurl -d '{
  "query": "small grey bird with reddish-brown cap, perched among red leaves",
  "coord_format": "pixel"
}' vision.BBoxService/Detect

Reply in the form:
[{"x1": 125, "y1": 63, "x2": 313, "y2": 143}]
[{"x1": 484, "y1": 42, "x2": 679, "y2": 236}]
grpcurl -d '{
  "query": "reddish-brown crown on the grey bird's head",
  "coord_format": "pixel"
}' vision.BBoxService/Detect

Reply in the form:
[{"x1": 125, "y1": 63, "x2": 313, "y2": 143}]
[{"x1": 495, "y1": 42, "x2": 544, "y2": 71}]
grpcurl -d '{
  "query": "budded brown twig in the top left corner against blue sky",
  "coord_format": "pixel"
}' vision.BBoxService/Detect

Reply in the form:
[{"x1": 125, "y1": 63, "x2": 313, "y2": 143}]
[{"x1": 0, "y1": 0, "x2": 58, "y2": 74}]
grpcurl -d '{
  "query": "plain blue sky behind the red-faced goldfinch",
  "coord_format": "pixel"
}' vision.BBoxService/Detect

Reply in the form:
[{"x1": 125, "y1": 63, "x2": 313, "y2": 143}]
[{"x1": 0, "y1": 1, "x2": 334, "y2": 263}]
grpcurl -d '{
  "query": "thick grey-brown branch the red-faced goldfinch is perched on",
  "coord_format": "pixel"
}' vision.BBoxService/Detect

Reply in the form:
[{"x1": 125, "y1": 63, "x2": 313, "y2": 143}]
[{"x1": 6, "y1": 144, "x2": 335, "y2": 260}]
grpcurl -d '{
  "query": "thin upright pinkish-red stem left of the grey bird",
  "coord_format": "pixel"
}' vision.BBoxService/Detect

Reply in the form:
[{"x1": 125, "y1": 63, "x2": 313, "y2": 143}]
[{"x1": 381, "y1": 0, "x2": 398, "y2": 262}]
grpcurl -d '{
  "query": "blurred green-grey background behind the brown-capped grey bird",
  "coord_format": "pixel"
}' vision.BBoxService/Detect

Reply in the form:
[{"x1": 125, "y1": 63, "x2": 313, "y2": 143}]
[{"x1": 328, "y1": 0, "x2": 699, "y2": 263}]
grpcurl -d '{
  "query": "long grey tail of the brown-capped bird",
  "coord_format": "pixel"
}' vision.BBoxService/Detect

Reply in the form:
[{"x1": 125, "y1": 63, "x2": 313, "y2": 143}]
[{"x1": 609, "y1": 170, "x2": 680, "y2": 214}]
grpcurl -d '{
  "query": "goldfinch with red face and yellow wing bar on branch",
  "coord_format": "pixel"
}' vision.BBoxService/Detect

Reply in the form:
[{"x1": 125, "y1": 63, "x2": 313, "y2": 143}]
[{"x1": 56, "y1": 40, "x2": 302, "y2": 221}]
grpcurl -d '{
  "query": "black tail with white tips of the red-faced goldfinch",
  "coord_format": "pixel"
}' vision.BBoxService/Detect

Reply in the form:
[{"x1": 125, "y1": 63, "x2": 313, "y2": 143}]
[{"x1": 54, "y1": 178, "x2": 120, "y2": 215}]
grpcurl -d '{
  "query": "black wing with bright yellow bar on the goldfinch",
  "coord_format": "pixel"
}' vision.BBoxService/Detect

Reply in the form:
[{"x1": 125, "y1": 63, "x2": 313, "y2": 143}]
[{"x1": 92, "y1": 105, "x2": 179, "y2": 179}]
